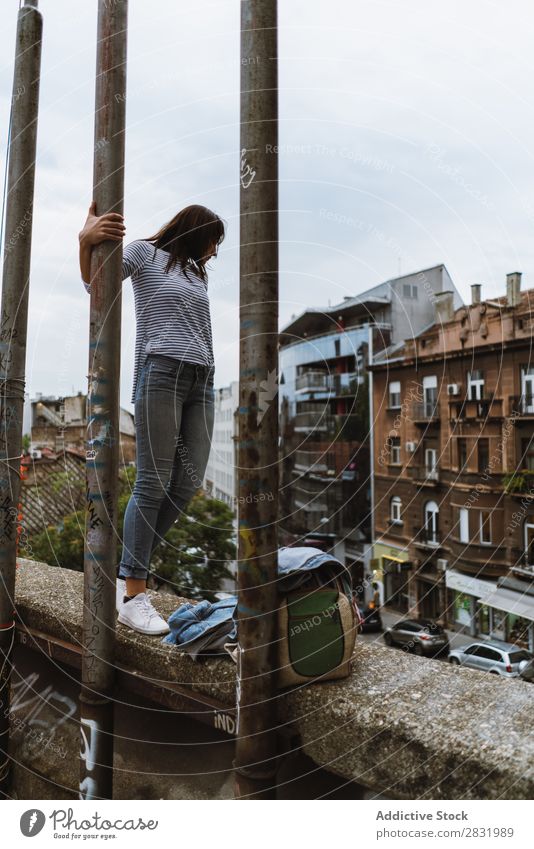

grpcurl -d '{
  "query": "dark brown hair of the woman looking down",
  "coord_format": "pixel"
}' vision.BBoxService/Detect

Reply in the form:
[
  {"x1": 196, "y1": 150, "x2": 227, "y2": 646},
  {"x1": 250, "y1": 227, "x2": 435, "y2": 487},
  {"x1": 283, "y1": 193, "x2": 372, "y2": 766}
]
[{"x1": 145, "y1": 204, "x2": 225, "y2": 283}]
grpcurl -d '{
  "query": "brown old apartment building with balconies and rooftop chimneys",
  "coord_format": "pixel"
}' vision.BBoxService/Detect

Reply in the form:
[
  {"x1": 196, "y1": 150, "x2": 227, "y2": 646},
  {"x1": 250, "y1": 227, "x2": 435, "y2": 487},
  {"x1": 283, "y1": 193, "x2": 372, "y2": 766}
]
[{"x1": 371, "y1": 273, "x2": 534, "y2": 649}]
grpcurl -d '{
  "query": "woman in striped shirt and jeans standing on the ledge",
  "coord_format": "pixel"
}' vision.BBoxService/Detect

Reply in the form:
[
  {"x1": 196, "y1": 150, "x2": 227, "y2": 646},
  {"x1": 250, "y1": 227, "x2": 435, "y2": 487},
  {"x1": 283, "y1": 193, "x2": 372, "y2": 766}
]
[{"x1": 80, "y1": 203, "x2": 225, "y2": 634}]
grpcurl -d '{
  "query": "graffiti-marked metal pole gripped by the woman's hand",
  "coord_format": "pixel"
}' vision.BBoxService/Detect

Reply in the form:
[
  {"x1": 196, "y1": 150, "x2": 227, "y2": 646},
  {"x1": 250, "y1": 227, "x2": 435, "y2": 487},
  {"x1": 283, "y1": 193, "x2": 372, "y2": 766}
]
[{"x1": 80, "y1": 0, "x2": 128, "y2": 799}]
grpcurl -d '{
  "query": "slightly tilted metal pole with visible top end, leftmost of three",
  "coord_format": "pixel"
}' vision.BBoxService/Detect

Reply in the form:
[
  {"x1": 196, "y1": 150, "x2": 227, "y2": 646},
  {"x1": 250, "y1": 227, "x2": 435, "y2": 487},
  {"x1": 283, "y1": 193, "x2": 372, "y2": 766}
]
[{"x1": 0, "y1": 0, "x2": 43, "y2": 798}]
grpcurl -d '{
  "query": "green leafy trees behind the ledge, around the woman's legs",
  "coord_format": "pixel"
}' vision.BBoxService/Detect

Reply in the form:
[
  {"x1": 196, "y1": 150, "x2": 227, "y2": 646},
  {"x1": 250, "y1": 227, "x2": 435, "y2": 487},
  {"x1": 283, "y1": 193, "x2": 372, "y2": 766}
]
[{"x1": 24, "y1": 467, "x2": 236, "y2": 598}]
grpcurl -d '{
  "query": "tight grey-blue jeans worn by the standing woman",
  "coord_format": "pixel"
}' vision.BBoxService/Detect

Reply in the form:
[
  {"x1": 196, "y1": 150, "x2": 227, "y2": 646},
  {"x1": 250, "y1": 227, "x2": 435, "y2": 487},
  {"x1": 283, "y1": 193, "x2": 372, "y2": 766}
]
[{"x1": 118, "y1": 354, "x2": 215, "y2": 579}]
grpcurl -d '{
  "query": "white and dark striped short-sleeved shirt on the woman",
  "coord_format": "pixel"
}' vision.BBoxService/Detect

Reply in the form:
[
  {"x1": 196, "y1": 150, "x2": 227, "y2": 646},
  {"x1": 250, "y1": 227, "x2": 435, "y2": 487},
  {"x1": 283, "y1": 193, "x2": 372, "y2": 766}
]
[{"x1": 84, "y1": 240, "x2": 214, "y2": 404}]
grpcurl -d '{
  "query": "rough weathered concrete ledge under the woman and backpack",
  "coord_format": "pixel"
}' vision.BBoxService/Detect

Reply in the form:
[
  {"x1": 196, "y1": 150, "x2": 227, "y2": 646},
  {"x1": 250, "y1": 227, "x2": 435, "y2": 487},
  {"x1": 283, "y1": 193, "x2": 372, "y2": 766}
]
[{"x1": 11, "y1": 560, "x2": 534, "y2": 799}]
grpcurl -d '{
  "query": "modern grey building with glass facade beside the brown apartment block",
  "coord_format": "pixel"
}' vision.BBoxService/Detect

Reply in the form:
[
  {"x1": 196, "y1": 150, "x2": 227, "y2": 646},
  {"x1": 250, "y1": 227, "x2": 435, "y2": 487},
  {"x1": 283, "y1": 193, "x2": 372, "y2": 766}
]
[{"x1": 279, "y1": 265, "x2": 461, "y2": 582}]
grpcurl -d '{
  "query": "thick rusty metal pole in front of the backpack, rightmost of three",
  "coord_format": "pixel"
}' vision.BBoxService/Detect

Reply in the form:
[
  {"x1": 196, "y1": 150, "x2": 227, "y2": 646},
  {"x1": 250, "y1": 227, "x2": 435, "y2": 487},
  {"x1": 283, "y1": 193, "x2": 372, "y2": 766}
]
[{"x1": 235, "y1": 0, "x2": 279, "y2": 799}]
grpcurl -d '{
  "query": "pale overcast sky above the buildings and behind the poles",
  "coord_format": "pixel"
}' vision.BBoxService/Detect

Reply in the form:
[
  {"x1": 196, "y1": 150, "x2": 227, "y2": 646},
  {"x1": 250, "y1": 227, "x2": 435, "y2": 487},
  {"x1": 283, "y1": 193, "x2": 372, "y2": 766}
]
[{"x1": 0, "y1": 0, "x2": 534, "y2": 409}]
